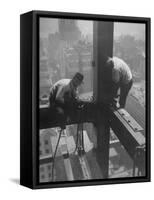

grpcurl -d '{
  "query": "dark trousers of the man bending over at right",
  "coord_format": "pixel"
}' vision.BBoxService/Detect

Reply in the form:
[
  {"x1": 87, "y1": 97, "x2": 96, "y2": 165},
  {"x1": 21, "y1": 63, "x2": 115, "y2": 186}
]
[{"x1": 119, "y1": 80, "x2": 133, "y2": 108}]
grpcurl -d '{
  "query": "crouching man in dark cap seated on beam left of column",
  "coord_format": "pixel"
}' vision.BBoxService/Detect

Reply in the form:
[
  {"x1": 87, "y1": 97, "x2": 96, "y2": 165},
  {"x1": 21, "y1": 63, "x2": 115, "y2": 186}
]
[{"x1": 49, "y1": 73, "x2": 84, "y2": 121}]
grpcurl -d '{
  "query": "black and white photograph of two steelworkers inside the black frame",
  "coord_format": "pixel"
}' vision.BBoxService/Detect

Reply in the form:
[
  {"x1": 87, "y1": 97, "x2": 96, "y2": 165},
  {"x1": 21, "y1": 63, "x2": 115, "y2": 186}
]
[{"x1": 37, "y1": 16, "x2": 148, "y2": 184}]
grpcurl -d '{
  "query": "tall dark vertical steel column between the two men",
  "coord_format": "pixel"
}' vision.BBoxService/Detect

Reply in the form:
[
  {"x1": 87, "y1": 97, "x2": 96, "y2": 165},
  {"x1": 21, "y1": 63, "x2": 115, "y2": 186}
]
[{"x1": 93, "y1": 21, "x2": 113, "y2": 178}]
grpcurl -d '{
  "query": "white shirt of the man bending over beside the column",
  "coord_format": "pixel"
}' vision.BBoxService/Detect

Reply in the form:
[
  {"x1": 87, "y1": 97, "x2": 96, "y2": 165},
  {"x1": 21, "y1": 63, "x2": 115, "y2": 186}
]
[{"x1": 112, "y1": 57, "x2": 132, "y2": 84}]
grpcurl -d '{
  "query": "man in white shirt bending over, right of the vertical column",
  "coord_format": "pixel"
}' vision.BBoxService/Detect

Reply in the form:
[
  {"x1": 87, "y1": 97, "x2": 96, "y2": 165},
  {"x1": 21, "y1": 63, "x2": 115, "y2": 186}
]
[{"x1": 106, "y1": 57, "x2": 133, "y2": 108}]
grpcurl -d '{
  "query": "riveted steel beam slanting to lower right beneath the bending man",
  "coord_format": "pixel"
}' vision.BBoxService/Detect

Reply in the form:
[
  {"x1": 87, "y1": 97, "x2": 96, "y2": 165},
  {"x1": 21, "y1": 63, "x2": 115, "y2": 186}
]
[{"x1": 109, "y1": 108, "x2": 146, "y2": 168}]
